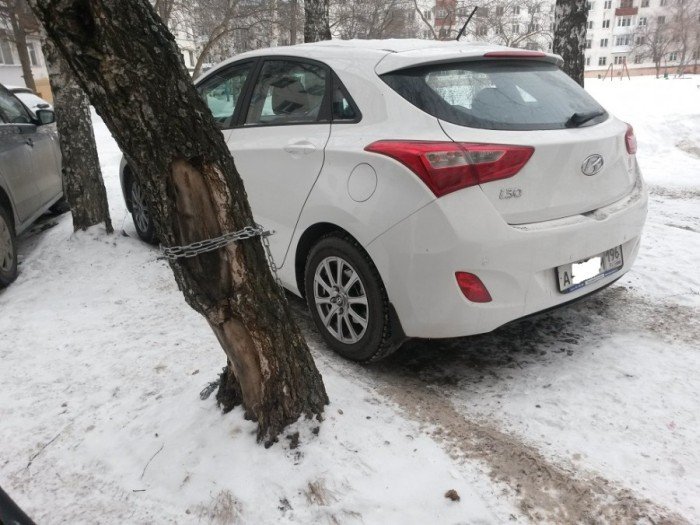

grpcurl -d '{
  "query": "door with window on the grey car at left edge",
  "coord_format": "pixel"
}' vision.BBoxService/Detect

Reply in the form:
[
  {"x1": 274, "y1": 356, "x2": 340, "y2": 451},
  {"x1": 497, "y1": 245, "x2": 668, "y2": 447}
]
[{"x1": 0, "y1": 86, "x2": 42, "y2": 222}]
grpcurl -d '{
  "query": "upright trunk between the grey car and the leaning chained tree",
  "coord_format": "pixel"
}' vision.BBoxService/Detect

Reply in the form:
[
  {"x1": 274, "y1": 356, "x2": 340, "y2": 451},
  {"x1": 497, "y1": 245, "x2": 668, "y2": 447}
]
[{"x1": 42, "y1": 39, "x2": 114, "y2": 233}]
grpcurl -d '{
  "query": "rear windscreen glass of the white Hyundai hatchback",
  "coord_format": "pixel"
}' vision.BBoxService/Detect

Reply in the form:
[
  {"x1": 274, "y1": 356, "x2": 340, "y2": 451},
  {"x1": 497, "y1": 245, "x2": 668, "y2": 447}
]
[{"x1": 382, "y1": 60, "x2": 607, "y2": 130}]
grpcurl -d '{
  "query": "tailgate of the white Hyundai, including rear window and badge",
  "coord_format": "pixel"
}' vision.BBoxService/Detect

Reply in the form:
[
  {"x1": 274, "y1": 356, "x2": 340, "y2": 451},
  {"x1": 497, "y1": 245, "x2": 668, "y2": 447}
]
[{"x1": 383, "y1": 60, "x2": 636, "y2": 224}]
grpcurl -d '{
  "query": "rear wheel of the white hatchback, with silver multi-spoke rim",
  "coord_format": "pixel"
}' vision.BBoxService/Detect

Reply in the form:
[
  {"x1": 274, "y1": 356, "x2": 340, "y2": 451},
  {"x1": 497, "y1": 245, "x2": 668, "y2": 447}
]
[{"x1": 304, "y1": 234, "x2": 400, "y2": 363}]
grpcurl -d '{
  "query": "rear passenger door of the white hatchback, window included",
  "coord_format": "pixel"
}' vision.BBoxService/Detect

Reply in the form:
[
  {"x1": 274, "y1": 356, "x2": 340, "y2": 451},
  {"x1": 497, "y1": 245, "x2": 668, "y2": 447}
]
[{"x1": 227, "y1": 58, "x2": 331, "y2": 266}]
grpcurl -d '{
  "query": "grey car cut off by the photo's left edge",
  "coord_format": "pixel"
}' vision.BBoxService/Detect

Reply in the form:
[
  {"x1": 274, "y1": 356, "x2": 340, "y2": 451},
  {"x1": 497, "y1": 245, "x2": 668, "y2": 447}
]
[{"x1": 0, "y1": 84, "x2": 63, "y2": 287}]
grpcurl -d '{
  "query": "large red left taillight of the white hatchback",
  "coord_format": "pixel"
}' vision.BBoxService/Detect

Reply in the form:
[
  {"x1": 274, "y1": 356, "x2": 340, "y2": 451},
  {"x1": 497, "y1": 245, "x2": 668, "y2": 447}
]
[{"x1": 365, "y1": 140, "x2": 535, "y2": 197}]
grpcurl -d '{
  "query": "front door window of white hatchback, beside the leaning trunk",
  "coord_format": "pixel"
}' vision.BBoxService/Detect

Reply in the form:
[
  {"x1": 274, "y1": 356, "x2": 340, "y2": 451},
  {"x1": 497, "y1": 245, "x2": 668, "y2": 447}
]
[{"x1": 197, "y1": 64, "x2": 252, "y2": 129}]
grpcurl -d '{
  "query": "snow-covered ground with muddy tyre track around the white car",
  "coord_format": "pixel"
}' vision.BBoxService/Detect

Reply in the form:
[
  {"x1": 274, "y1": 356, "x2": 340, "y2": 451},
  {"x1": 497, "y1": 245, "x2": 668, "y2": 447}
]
[{"x1": 0, "y1": 77, "x2": 700, "y2": 524}]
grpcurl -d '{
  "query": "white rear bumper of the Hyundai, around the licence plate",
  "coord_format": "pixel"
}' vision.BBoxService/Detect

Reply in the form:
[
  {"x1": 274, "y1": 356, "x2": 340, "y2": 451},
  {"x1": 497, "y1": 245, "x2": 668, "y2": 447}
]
[{"x1": 368, "y1": 178, "x2": 648, "y2": 338}]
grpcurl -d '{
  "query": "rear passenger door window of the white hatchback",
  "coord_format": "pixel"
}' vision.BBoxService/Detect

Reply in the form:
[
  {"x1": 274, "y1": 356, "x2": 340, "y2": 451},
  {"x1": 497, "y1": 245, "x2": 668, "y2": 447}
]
[{"x1": 245, "y1": 60, "x2": 328, "y2": 126}]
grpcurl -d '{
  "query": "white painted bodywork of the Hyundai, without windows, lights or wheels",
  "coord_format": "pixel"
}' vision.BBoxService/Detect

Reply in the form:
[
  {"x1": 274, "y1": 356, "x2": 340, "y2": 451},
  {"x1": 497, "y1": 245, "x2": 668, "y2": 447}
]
[{"x1": 124, "y1": 40, "x2": 647, "y2": 338}]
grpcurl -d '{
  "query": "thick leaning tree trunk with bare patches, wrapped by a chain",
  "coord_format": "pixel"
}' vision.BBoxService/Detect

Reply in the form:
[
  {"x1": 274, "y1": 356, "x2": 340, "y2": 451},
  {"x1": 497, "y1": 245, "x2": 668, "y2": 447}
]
[{"x1": 30, "y1": 0, "x2": 328, "y2": 444}]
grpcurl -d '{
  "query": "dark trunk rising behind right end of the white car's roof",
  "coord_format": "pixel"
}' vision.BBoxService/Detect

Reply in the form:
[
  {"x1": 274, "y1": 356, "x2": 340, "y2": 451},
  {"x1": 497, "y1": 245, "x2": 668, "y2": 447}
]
[{"x1": 552, "y1": 0, "x2": 588, "y2": 87}]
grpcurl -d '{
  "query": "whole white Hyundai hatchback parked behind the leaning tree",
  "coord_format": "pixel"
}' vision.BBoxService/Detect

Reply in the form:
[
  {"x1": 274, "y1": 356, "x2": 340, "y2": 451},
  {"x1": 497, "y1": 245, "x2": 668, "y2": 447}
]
[{"x1": 122, "y1": 40, "x2": 647, "y2": 361}]
